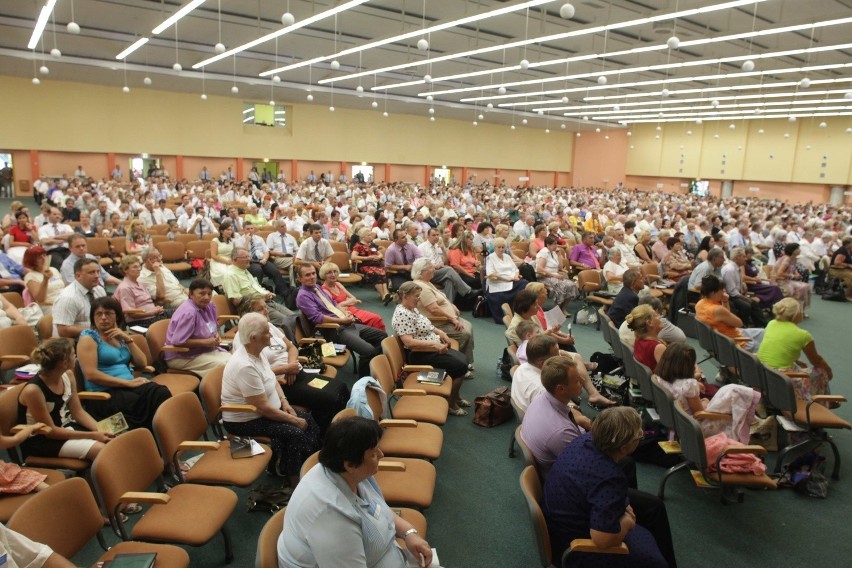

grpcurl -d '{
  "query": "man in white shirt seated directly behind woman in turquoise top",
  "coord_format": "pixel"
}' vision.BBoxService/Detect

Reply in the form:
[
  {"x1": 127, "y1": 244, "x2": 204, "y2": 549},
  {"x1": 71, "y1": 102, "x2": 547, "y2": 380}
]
[{"x1": 53, "y1": 258, "x2": 106, "y2": 339}]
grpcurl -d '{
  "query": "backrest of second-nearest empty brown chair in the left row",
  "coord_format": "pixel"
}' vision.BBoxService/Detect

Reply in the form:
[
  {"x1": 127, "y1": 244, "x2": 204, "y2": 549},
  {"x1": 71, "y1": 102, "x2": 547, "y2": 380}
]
[{"x1": 91, "y1": 428, "x2": 163, "y2": 518}]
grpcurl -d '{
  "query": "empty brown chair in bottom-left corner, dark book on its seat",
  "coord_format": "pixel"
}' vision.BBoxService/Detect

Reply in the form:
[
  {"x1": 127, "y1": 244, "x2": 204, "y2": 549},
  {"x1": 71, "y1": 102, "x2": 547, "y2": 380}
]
[{"x1": 7, "y1": 477, "x2": 189, "y2": 568}]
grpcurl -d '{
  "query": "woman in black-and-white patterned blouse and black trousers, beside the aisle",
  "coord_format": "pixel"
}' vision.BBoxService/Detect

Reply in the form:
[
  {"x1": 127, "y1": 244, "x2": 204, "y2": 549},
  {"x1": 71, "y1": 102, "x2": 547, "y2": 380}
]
[{"x1": 391, "y1": 282, "x2": 473, "y2": 416}]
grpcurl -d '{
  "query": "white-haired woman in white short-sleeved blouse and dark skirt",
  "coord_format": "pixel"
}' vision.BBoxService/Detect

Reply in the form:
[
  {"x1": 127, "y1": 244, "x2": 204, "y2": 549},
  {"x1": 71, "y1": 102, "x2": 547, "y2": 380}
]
[{"x1": 222, "y1": 312, "x2": 320, "y2": 487}]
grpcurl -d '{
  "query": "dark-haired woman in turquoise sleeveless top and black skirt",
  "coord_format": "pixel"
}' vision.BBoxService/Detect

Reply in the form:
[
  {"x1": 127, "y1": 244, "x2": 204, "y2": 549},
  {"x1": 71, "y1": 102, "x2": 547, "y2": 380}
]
[{"x1": 77, "y1": 296, "x2": 171, "y2": 430}]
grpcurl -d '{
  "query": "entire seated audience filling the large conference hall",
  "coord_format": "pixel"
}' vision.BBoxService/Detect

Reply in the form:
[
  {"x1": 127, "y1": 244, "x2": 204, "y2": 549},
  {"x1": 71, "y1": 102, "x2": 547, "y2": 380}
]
[{"x1": 0, "y1": 170, "x2": 852, "y2": 567}]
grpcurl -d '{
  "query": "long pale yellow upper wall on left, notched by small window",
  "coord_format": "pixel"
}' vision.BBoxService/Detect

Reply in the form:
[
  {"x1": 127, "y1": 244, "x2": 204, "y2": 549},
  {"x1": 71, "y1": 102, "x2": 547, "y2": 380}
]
[{"x1": 0, "y1": 76, "x2": 573, "y2": 172}]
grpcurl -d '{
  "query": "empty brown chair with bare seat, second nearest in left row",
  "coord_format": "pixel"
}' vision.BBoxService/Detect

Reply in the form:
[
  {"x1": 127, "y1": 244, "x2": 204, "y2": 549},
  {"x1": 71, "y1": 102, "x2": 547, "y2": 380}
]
[{"x1": 92, "y1": 428, "x2": 237, "y2": 563}]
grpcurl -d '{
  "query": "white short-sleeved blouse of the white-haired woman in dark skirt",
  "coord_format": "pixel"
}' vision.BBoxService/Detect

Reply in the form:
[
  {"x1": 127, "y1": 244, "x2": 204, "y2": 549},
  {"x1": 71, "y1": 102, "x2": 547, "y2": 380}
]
[{"x1": 222, "y1": 349, "x2": 281, "y2": 422}]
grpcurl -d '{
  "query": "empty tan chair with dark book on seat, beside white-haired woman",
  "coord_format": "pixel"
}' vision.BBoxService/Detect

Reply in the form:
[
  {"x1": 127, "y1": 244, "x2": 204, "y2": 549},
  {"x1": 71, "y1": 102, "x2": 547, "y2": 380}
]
[{"x1": 154, "y1": 392, "x2": 272, "y2": 487}]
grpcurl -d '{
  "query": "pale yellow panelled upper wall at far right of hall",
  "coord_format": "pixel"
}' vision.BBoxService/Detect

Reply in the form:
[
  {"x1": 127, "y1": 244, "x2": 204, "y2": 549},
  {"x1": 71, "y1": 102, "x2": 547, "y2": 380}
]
[{"x1": 626, "y1": 117, "x2": 852, "y2": 184}]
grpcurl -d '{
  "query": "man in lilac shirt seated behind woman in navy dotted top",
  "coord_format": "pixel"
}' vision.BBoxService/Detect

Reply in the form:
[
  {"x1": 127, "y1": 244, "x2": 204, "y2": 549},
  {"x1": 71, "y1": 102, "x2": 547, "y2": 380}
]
[{"x1": 521, "y1": 355, "x2": 589, "y2": 477}]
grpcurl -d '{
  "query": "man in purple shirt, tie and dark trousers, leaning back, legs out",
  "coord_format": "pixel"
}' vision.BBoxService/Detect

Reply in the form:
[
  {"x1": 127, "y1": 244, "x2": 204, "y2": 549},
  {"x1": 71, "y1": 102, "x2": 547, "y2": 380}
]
[{"x1": 296, "y1": 264, "x2": 387, "y2": 377}]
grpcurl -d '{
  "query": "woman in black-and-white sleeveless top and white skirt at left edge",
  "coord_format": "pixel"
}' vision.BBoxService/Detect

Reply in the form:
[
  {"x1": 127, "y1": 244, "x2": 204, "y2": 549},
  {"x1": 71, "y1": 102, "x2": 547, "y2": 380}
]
[{"x1": 18, "y1": 338, "x2": 112, "y2": 460}]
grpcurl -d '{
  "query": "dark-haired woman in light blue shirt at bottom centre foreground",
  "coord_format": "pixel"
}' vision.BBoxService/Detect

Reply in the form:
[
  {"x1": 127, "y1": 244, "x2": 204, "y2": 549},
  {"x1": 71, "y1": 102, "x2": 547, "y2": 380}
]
[{"x1": 278, "y1": 416, "x2": 432, "y2": 568}]
